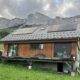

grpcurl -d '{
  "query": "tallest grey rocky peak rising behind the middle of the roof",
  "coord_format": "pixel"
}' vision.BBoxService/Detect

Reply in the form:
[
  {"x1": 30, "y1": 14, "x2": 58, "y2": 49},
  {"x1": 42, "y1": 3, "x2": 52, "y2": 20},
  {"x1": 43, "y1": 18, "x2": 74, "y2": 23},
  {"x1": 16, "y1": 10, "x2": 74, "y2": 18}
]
[{"x1": 26, "y1": 12, "x2": 53, "y2": 25}]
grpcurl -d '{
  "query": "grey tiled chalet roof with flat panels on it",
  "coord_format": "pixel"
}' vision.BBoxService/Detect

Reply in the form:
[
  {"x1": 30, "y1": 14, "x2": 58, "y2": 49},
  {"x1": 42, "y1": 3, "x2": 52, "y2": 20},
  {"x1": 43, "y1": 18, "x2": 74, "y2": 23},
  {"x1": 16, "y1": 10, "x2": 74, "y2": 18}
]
[{"x1": 1, "y1": 22, "x2": 80, "y2": 42}]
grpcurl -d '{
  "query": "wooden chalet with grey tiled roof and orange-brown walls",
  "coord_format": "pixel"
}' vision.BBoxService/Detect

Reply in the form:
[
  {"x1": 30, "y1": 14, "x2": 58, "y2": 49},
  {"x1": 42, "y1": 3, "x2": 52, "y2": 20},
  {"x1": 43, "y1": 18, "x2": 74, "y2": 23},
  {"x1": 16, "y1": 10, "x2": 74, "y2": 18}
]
[{"x1": 1, "y1": 23, "x2": 80, "y2": 72}]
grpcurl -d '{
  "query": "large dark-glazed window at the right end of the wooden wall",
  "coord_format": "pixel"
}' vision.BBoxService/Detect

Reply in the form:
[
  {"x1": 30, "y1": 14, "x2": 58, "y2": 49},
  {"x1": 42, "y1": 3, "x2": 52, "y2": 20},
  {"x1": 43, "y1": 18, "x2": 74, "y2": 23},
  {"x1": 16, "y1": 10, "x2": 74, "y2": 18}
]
[{"x1": 55, "y1": 43, "x2": 72, "y2": 58}]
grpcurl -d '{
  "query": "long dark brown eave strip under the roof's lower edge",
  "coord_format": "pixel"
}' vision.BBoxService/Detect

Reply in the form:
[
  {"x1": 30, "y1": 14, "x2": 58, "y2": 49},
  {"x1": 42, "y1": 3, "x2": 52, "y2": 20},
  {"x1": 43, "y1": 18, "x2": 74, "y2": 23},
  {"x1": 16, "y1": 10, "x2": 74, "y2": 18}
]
[{"x1": 2, "y1": 38, "x2": 78, "y2": 43}]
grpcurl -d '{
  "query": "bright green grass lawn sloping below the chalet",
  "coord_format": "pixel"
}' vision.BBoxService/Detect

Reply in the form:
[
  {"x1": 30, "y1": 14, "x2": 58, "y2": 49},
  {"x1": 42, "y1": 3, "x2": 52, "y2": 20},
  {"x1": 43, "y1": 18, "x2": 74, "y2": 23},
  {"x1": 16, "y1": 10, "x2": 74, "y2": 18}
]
[{"x1": 0, "y1": 63, "x2": 80, "y2": 80}]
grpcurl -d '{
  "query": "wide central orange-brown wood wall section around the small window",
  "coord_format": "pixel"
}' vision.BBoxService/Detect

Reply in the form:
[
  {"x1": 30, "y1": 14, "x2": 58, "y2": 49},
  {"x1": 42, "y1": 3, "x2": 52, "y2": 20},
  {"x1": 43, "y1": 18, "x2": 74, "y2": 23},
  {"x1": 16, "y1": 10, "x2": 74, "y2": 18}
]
[{"x1": 18, "y1": 43, "x2": 54, "y2": 57}]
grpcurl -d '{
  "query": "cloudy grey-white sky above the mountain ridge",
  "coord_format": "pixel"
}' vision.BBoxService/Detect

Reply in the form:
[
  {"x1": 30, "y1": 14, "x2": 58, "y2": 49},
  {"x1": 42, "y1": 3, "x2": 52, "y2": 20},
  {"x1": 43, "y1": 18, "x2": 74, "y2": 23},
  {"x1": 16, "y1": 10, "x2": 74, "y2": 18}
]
[{"x1": 0, "y1": 0, "x2": 80, "y2": 19}]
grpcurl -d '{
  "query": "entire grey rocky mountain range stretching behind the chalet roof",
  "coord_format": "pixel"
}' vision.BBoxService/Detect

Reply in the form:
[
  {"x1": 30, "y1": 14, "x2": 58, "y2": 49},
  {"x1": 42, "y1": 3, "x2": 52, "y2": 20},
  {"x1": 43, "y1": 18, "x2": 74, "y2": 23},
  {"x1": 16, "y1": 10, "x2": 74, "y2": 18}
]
[{"x1": 0, "y1": 12, "x2": 80, "y2": 30}]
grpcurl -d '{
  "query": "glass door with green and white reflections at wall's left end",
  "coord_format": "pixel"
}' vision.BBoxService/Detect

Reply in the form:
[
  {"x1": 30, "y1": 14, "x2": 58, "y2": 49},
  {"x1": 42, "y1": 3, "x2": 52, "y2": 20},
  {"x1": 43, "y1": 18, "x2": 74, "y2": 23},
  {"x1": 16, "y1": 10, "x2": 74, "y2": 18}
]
[{"x1": 8, "y1": 44, "x2": 18, "y2": 57}]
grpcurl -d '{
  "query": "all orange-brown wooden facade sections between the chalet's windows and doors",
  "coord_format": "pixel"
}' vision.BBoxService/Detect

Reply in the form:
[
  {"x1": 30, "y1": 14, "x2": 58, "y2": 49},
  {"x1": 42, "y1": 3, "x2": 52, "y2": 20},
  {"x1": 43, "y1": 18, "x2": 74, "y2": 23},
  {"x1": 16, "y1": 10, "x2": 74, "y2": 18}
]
[{"x1": 3, "y1": 42, "x2": 77, "y2": 58}]
